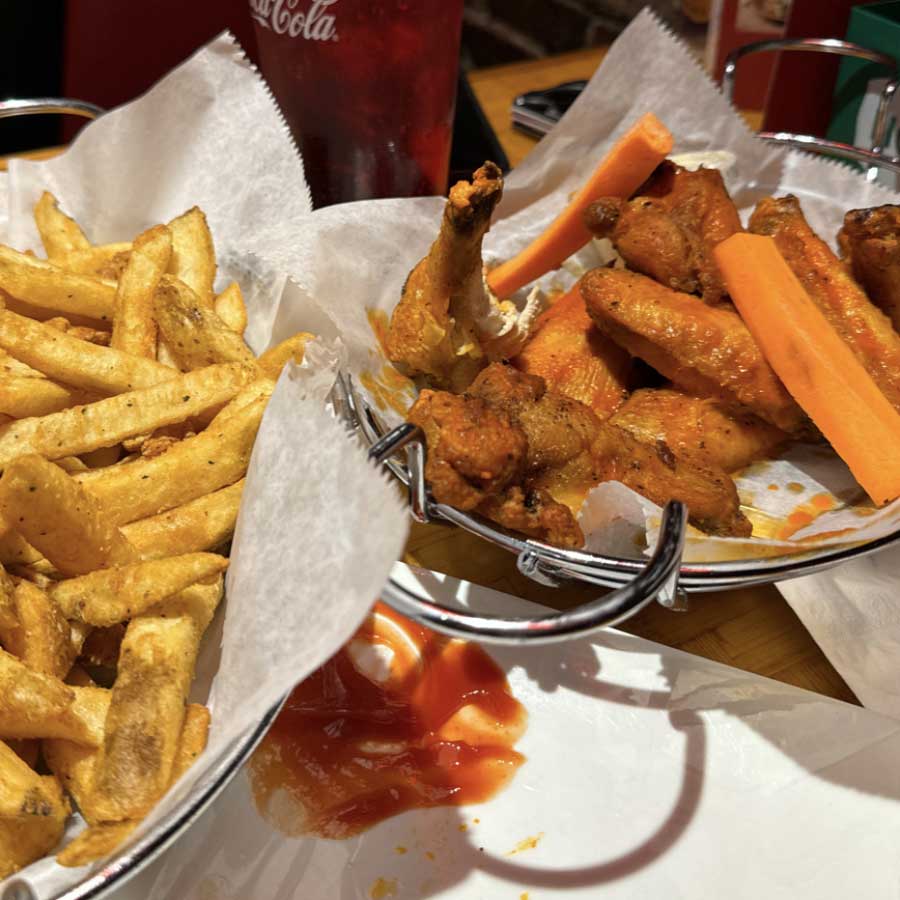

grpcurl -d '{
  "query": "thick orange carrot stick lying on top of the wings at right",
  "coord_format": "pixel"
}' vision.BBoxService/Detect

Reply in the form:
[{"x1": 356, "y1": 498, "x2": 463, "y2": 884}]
[{"x1": 713, "y1": 234, "x2": 900, "y2": 505}]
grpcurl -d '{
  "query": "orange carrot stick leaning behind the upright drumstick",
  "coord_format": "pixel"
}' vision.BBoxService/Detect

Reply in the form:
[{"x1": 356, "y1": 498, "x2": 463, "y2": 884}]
[{"x1": 488, "y1": 113, "x2": 673, "y2": 298}]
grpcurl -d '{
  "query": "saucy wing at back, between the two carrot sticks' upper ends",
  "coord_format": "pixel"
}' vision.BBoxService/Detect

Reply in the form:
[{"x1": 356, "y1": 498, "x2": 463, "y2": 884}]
[{"x1": 585, "y1": 161, "x2": 742, "y2": 304}]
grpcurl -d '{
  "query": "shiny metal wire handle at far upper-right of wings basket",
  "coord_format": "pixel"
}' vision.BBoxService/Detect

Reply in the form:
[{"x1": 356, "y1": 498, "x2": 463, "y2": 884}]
[{"x1": 722, "y1": 38, "x2": 900, "y2": 181}]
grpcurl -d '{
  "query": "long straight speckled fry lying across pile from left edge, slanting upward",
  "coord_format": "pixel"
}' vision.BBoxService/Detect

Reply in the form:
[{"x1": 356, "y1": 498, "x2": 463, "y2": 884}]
[{"x1": 0, "y1": 362, "x2": 255, "y2": 467}]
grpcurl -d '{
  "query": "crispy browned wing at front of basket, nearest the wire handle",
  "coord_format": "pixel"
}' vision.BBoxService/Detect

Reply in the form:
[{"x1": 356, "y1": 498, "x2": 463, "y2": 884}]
[{"x1": 409, "y1": 363, "x2": 750, "y2": 547}]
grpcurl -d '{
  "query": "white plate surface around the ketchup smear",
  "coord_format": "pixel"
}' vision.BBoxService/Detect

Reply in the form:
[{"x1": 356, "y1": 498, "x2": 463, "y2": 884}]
[{"x1": 110, "y1": 564, "x2": 900, "y2": 900}]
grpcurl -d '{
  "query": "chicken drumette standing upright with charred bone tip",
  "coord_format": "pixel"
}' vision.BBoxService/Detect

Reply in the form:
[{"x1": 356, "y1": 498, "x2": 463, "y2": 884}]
[{"x1": 387, "y1": 163, "x2": 503, "y2": 391}]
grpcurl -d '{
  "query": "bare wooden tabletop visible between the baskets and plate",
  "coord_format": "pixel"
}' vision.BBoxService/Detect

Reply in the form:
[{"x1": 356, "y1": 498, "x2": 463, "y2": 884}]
[{"x1": 0, "y1": 49, "x2": 857, "y2": 703}]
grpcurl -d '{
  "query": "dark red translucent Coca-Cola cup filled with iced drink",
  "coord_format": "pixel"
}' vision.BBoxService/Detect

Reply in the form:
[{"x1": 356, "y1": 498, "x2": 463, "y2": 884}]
[{"x1": 249, "y1": 0, "x2": 462, "y2": 207}]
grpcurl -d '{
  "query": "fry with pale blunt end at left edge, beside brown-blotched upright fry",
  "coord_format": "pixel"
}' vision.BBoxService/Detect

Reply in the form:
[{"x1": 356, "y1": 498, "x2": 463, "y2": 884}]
[{"x1": 0, "y1": 650, "x2": 103, "y2": 747}]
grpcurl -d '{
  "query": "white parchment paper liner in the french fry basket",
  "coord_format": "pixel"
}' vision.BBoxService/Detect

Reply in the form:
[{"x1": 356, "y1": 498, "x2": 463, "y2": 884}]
[{"x1": 5, "y1": 35, "x2": 407, "y2": 898}]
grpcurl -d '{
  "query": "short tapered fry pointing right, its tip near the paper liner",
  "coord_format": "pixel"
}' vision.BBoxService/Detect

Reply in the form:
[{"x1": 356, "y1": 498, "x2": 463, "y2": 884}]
[{"x1": 50, "y1": 553, "x2": 228, "y2": 625}]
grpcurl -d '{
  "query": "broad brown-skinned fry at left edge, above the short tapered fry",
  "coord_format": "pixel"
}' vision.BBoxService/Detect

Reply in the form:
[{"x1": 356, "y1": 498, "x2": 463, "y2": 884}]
[{"x1": 0, "y1": 454, "x2": 137, "y2": 575}]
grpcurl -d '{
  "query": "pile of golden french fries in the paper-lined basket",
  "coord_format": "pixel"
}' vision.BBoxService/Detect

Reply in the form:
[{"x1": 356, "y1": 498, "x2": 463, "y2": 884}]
[{"x1": 0, "y1": 193, "x2": 310, "y2": 878}]
